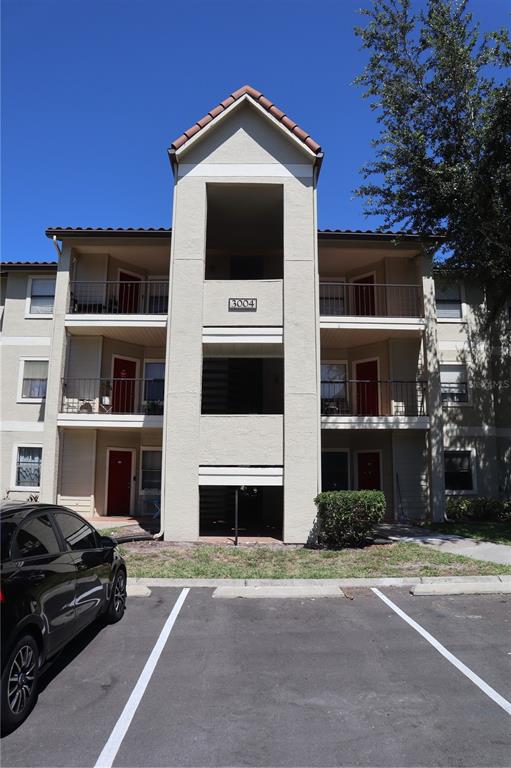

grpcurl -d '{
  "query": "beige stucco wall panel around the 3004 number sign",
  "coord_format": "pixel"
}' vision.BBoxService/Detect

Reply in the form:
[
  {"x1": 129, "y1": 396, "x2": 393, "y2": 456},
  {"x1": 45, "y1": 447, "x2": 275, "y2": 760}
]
[{"x1": 202, "y1": 280, "x2": 282, "y2": 327}]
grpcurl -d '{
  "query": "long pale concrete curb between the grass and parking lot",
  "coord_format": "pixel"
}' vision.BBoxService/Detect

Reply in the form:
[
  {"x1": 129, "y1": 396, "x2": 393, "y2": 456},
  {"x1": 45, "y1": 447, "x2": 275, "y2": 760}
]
[{"x1": 128, "y1": 575, "x2": 511, "y2": 592}]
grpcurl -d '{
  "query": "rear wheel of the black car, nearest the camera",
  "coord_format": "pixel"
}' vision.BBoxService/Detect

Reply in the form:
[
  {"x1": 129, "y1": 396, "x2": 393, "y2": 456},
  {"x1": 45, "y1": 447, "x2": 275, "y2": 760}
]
[{"x1": 2, "y1": 635, "x2": 40, "y2": 733}]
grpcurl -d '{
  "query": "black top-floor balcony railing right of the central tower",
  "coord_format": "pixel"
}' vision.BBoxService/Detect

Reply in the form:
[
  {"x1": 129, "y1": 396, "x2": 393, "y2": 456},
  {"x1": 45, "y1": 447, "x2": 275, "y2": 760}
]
[{"x1": 319, "y1": 281, "x2": 424, "y2": 317}]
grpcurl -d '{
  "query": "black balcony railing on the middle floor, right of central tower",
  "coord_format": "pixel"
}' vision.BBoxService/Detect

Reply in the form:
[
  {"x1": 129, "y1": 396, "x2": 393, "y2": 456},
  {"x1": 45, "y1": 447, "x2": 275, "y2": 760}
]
[{"x1": 321, "y1": 379, "x2": 427, "y2": 416}]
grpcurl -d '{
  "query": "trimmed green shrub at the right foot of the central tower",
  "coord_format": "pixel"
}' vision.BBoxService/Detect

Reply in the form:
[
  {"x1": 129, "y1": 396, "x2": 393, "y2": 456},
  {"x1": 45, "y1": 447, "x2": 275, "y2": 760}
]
[{"x1": 314, "y1": 491, "x2": 385, "y2": 549}]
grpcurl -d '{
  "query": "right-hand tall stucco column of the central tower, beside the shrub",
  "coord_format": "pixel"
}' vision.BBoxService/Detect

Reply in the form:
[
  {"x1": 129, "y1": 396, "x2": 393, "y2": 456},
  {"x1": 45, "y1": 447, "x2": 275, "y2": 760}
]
[{"x1": 284, "y1": 179, "x2": 321, "y2": 543}]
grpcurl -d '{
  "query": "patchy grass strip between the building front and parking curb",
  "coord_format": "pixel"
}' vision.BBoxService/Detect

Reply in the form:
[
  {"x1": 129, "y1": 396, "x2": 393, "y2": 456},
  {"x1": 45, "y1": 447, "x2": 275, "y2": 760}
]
[{"x1": 122, "y1": 542, "x2": 511, "y2": 579}]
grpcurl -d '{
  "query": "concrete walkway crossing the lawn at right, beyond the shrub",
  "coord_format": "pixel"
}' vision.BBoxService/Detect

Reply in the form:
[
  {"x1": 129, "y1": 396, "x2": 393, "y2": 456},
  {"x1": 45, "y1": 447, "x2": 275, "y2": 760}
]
[{"x1": 378, "y1": 525, "x2": 511, "y2": 565}]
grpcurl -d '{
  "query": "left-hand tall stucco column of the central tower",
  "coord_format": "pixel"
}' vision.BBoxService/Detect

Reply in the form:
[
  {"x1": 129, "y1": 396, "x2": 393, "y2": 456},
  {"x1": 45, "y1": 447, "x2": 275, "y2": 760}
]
[{"x1": 163, "y1": 178, "x2": 206, "y2": 541}]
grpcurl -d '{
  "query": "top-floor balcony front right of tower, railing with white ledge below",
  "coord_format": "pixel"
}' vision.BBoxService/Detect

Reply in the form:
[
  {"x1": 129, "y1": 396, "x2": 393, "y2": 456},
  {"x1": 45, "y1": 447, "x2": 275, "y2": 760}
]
[{"x1": 319, "y1": 278, "x2": 424, "y2": 330}]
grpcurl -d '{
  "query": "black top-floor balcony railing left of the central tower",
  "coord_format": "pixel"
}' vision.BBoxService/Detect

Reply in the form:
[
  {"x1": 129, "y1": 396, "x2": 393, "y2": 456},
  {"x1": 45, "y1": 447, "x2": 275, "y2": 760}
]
[{"x1": 69, "y1": 280, "x2": 169, "y2": 315}]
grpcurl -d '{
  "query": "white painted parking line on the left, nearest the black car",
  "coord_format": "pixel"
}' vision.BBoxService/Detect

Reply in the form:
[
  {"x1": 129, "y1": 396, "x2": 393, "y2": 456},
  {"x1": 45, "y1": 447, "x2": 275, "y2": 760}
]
[{"x1": 94, "y1": 587, "x2": 190, "y2": 768}]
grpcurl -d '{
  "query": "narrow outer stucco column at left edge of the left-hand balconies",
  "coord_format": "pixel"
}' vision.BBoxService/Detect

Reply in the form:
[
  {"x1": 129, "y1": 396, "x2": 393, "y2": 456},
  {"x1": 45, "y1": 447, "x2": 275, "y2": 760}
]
[{"x1": 39, "y1": 245, "x2": 71, "y2": 504}]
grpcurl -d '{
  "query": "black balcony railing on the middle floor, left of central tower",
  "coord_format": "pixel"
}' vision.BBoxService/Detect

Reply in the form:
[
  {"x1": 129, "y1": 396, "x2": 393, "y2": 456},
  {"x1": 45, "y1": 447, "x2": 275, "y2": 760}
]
[{"x1": 61, "y1": 378, "x2": 164, "y2": 415}]
